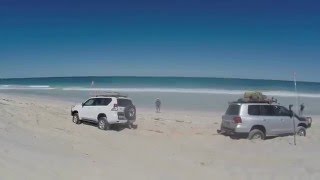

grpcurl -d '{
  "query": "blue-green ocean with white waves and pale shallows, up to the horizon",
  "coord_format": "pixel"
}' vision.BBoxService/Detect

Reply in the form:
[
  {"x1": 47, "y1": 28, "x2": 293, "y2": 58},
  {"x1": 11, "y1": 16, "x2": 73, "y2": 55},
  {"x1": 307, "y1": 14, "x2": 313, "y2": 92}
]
[{"x1": 0, "y1": 77, "x2": 320, "y2": 114}]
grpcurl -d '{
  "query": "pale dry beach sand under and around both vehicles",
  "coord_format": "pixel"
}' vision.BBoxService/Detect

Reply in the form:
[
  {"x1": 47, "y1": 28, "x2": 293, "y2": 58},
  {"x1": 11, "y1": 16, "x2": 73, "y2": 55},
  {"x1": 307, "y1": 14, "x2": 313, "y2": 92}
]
[{"x1": 0, "y1": 94, "x2": 320, "y2": 180}]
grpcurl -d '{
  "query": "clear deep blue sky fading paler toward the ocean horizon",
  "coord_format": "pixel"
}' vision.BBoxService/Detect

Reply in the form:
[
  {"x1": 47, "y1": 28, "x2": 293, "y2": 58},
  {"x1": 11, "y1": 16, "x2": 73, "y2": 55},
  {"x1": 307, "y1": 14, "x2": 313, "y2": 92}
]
[{"x1": 0, "y1": 0, "x2": 320, "y2": 81}]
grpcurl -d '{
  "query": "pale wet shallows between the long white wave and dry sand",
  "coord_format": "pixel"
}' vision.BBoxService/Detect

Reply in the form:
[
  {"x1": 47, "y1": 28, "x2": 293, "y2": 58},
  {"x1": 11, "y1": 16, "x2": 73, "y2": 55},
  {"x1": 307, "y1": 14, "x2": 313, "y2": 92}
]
[{"x1": 0, "y1": 90, "x2": 320, "y2": 116}]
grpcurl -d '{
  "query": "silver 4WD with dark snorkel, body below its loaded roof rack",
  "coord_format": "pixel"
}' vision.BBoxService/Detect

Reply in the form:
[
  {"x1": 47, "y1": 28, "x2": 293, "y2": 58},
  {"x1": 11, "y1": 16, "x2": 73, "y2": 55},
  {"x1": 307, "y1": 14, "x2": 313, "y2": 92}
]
[{"x1": 218, "y1": 102, "x2": 311, "y2": 139}]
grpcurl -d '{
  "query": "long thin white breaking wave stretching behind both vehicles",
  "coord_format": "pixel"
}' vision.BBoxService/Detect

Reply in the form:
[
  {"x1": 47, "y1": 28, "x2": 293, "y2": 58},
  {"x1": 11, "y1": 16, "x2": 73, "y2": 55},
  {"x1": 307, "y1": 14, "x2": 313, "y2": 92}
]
[{"x1": 62, "y1": 87, "x2": 320, "y2": 98}]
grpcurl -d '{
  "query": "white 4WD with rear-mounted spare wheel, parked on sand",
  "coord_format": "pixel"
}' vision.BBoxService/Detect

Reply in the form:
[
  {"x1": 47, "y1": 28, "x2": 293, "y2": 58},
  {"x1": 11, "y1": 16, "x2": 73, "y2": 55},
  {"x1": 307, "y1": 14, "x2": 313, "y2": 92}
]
[{"x1": 71, "y1": 93, "x2": 136, "y2": 130}]
